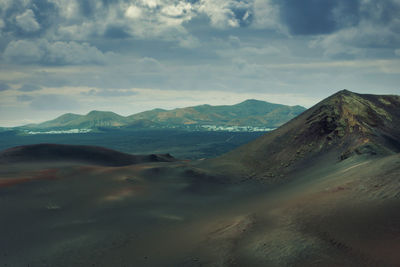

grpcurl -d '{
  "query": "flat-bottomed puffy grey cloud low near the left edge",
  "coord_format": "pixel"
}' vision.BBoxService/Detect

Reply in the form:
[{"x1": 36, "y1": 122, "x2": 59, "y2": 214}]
[{"x1": 3, "y1": 39, "x2": 106, "y2": 65}]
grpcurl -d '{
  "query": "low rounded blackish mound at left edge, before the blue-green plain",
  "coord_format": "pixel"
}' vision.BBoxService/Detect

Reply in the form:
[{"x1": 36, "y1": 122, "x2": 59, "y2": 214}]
[{"x1": 0, "y1": 144, "x2": 174, "y2": 166}]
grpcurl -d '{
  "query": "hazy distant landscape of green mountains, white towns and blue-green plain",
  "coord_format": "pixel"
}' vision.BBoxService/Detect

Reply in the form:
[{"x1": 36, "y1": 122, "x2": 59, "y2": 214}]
[{"x1": 0, "y1": 100, "x2": 305, "y2": 159}]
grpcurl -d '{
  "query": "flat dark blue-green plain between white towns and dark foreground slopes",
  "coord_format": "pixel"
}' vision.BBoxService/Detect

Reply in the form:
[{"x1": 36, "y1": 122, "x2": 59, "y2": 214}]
[{"x1": 0, "y1": 129, "x2": 264, "y2": 159}]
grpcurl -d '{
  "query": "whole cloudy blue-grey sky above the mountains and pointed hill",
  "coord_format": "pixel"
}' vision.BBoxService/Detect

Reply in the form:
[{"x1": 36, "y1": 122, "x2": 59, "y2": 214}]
[{"x1": 0, "y1": 0, "x2": 400, "y2": 126}]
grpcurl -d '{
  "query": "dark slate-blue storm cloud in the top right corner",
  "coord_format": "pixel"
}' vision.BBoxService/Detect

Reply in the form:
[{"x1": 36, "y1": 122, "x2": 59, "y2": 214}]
[{"x1": 275, "y1": 0, "x2": 400, "y2": 35}]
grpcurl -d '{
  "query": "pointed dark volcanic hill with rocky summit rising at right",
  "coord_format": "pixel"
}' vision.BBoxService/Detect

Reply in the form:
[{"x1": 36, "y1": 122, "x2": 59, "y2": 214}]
[{"x1": 210, "y1": 90, "x2": 400, "y2": 178}]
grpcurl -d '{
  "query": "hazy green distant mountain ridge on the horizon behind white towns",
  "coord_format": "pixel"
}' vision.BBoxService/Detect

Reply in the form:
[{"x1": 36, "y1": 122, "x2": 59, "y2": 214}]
[{"x1": 18, "y1": 99, "x2": 306, "y2": 129}]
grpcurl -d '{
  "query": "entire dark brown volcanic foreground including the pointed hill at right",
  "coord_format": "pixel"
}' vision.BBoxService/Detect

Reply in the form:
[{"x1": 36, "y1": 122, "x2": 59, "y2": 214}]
[{"x1": 0, "y1": 91, "x2": 400, "y2": 266}]
